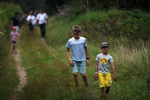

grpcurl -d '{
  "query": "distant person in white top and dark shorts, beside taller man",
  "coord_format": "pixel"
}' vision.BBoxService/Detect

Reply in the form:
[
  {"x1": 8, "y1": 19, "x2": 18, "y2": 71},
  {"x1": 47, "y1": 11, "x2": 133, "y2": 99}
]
[{"x1": 26, "y1": 11, "x2": 36, "y2": 35}]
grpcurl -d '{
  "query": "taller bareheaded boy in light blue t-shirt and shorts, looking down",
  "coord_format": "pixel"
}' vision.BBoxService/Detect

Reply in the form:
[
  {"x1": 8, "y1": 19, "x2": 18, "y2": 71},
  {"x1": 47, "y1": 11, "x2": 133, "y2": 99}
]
[{"x1": 66, "y1": 25, "x2": 89, "y2": 86}]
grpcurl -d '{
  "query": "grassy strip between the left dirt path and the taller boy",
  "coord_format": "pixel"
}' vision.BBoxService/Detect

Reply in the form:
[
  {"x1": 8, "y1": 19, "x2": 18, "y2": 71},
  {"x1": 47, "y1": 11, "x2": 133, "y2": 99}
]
[{"x1": 19, "y1": 26, "x2": 98, "y2": 100}]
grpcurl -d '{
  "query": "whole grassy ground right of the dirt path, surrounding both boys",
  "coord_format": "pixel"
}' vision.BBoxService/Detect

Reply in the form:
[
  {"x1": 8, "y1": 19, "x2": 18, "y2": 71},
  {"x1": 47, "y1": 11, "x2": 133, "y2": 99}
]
[{"x1": 7, "y1": 9, "x2": 150, "y2": 100}]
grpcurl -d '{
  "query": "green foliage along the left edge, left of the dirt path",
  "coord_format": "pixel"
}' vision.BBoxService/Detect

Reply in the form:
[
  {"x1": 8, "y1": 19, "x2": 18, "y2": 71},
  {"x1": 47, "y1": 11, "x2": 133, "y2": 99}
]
[{"x1": 0, "y1": 2, "x2": 22, "y2": 100}]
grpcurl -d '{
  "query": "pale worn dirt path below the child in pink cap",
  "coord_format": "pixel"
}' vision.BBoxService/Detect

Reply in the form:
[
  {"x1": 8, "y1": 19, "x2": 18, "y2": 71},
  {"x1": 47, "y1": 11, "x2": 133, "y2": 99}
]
[{"x1": 10, "y1": 50, "x2": 27, "y2": 100}]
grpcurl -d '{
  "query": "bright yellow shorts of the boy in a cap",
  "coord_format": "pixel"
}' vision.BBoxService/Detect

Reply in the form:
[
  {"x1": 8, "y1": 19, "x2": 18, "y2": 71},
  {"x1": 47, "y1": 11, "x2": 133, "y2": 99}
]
[{"x1": 98, "y1": 72, "x2": 112, "y2": 88}]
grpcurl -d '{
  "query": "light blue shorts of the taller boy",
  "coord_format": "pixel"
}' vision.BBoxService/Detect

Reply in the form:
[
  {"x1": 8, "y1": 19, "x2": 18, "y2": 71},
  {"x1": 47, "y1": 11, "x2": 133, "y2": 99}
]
[{"x1": 72, "y1": 61, "x2": 86, "y2": 74}]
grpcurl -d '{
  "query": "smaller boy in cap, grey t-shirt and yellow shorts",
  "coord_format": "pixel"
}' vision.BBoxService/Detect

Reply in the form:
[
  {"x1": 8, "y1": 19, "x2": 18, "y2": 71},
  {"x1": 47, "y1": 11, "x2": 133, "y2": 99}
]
[{"x1": 95, "y1": 42, "x2": 117, "y2": 100}]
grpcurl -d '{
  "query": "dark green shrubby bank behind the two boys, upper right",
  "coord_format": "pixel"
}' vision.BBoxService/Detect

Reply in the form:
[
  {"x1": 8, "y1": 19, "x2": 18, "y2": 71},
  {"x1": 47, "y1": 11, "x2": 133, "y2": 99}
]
[{"x1": 79, "y1": 10, "x2": 150, "y2": 41}]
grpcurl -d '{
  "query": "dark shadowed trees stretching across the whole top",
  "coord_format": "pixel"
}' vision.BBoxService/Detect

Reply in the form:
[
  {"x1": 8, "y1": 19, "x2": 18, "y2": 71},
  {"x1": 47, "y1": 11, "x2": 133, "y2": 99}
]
[{"x1": 1, "y1": 0, "x2": 150, "y2": 14}]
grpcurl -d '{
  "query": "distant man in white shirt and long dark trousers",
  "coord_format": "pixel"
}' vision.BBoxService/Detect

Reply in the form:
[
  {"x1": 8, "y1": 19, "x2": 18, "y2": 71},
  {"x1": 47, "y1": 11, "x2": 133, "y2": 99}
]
[{"x1": 36, "y1": 9, "x2": 48, "y2": 38}]
